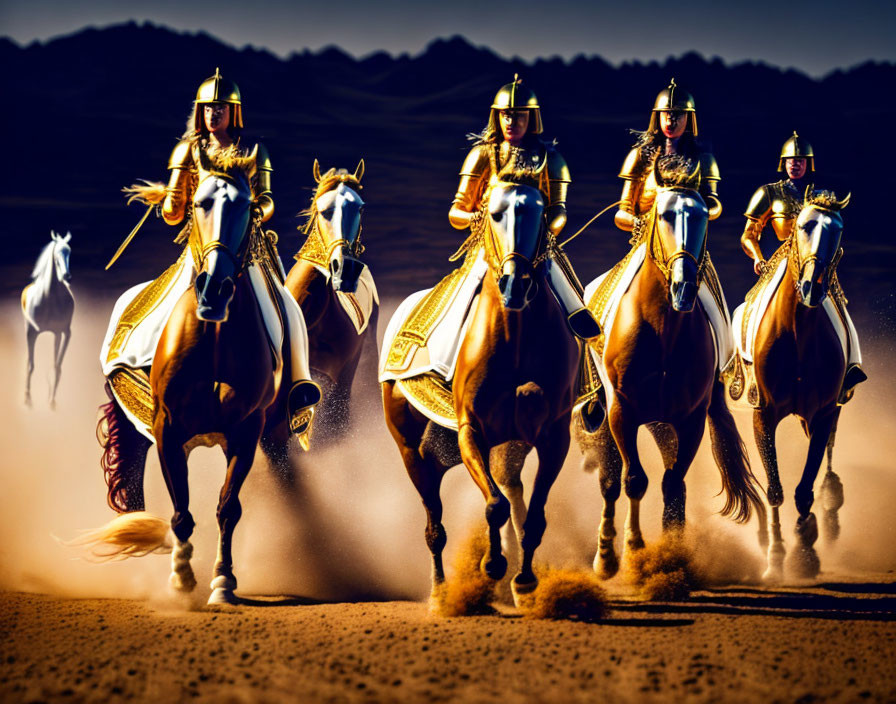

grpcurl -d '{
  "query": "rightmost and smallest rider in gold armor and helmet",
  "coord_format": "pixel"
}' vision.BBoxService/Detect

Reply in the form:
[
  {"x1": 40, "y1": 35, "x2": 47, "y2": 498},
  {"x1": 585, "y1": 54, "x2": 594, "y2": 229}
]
[{"x1": 740, "y1": 132, "x2": 868, "y2": 402}]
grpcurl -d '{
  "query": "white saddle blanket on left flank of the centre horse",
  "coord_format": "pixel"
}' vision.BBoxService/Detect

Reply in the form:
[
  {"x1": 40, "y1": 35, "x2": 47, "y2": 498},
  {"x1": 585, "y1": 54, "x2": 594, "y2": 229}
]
[{"x1": 379, "y1": 250, "x2": 488, "y2": 382}]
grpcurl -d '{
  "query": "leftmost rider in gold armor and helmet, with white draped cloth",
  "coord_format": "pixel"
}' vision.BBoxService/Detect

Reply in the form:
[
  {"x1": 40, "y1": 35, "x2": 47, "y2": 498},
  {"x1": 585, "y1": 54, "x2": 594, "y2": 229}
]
[{"x1": 101, "y1": 69, "x2": 320, "y2": 440}]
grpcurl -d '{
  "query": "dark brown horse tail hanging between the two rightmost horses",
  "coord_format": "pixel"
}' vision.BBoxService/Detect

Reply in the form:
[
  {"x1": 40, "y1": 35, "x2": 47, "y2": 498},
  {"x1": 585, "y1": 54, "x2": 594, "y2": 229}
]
[{"x1": 709, "y1": 378, "x2": 765, "y2": 523}]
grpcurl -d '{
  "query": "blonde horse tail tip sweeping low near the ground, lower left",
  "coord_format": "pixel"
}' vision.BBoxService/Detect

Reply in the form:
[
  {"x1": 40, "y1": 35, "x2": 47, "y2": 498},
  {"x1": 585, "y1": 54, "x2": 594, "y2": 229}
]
[{"x1": 65, "y1": 511, "x2": 173, "y2": 562}]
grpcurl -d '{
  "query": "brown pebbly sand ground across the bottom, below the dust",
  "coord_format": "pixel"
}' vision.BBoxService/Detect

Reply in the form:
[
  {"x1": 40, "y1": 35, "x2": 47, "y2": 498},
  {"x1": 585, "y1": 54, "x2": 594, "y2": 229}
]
[{"x1": 0, "y1": 583, "x2": 896, "y2": 702}]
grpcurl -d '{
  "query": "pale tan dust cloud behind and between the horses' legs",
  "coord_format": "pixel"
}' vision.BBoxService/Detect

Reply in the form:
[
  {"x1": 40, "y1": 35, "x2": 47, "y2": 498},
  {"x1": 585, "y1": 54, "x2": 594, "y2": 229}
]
[{"x1": 0, "y1": 291, "x2": 896, "y2": 601}]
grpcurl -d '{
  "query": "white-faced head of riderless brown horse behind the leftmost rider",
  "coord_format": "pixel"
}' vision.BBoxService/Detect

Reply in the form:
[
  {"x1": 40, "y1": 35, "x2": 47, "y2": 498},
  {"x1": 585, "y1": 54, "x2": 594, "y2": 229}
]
[{"x1": 309, "y1": 159, "x2": 364, "y2": 293}]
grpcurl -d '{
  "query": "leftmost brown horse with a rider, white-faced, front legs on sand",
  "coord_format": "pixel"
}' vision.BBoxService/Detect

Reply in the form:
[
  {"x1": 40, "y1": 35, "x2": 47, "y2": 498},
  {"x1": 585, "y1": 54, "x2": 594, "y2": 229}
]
[{"x1": 84, "y1": 172, "x2": 291, "y2": 603}]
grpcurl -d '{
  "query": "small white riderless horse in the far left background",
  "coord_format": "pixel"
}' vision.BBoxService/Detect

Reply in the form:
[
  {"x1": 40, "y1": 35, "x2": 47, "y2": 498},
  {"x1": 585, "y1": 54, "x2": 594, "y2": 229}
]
[{"x1": 22, "y1": 231, "x2": 75, "y2": 410}]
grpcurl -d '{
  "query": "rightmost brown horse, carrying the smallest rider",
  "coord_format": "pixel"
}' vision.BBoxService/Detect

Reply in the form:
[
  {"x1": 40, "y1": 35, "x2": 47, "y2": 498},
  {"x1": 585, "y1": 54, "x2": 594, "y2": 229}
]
[{"x1": 736, "y1": 187, "x2": 849, "y2": 581}]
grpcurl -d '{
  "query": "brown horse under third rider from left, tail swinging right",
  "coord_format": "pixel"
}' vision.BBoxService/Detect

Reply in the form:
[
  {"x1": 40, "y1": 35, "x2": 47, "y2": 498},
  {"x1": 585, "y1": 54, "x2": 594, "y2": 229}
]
[{"x1": 579, "y1": 188, "x2": 763, "y2": 578}]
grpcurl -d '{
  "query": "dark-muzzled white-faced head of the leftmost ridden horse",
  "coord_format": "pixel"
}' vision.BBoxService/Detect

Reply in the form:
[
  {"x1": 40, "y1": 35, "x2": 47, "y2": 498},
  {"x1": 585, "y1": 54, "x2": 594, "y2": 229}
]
[{"x1": 193, "y1": 173, "x2": 252, "y2": 323}]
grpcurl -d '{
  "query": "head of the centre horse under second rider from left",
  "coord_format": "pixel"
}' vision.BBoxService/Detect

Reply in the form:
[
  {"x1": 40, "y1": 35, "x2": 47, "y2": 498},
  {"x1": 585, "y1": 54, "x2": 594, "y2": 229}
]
[{"x1": 485, "y1": 182, "x2": 544, "y2": 310}]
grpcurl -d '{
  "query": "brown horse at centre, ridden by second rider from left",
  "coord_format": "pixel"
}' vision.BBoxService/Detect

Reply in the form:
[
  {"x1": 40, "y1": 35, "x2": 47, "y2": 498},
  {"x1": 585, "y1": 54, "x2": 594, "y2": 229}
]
[{"x1": 383, "y1": 183, "x2": 579, "y2": 596}]
